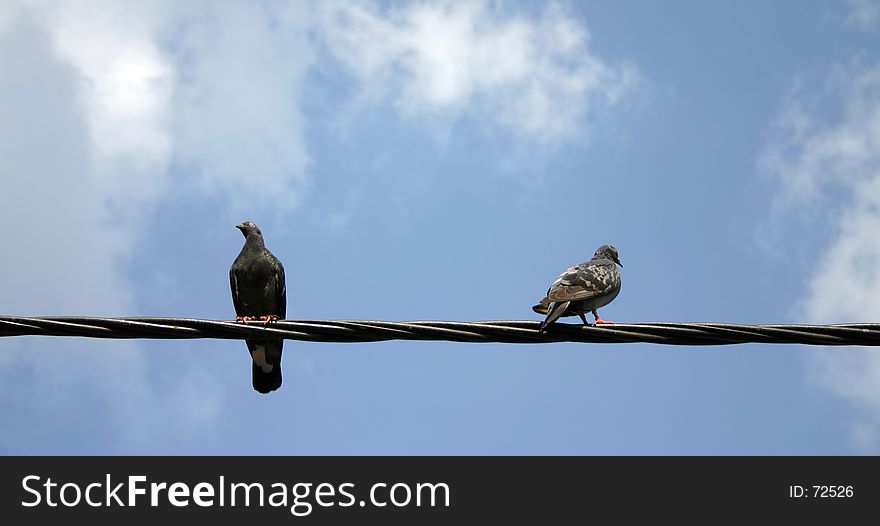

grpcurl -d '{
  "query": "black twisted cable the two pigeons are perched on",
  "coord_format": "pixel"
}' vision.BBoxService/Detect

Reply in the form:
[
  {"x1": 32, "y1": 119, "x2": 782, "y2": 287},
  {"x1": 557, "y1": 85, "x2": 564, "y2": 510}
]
[{"x1": 0, "y1": 316, "x2": 880, "y2": 346}]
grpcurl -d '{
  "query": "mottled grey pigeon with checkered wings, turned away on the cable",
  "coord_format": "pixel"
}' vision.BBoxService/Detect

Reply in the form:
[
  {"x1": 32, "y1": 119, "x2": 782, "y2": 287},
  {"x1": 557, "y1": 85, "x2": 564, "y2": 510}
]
[{"x1": 532, "y1": 245, "x2": 623, "y2": 331}]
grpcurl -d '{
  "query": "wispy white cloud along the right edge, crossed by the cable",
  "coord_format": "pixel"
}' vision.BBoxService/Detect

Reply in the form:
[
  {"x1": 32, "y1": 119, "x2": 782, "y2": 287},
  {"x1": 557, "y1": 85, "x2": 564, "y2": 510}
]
[{"x1": 764, "y1": 60, "x2": 880, "y2": 446}]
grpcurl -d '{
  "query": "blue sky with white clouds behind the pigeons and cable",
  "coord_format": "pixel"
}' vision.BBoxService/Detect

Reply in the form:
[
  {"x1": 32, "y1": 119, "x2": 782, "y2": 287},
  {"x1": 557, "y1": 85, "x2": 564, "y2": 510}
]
[{"x1": 0, "y1": 0, "x2": 880, "y2": 455}]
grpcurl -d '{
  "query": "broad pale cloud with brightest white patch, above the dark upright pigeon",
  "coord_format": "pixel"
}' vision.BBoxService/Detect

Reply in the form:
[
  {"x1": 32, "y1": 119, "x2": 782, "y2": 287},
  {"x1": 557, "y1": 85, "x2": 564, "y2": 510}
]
[{"x1": 21, "y1": 1, "x2": 313, "y2": 224}]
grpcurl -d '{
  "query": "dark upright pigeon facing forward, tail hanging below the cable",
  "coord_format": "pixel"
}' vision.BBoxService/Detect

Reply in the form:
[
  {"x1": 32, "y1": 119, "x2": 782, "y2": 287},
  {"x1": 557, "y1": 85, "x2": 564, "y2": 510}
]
[{"x1": 229, "y1": 221, "x2": 287, "y2": 394}]
